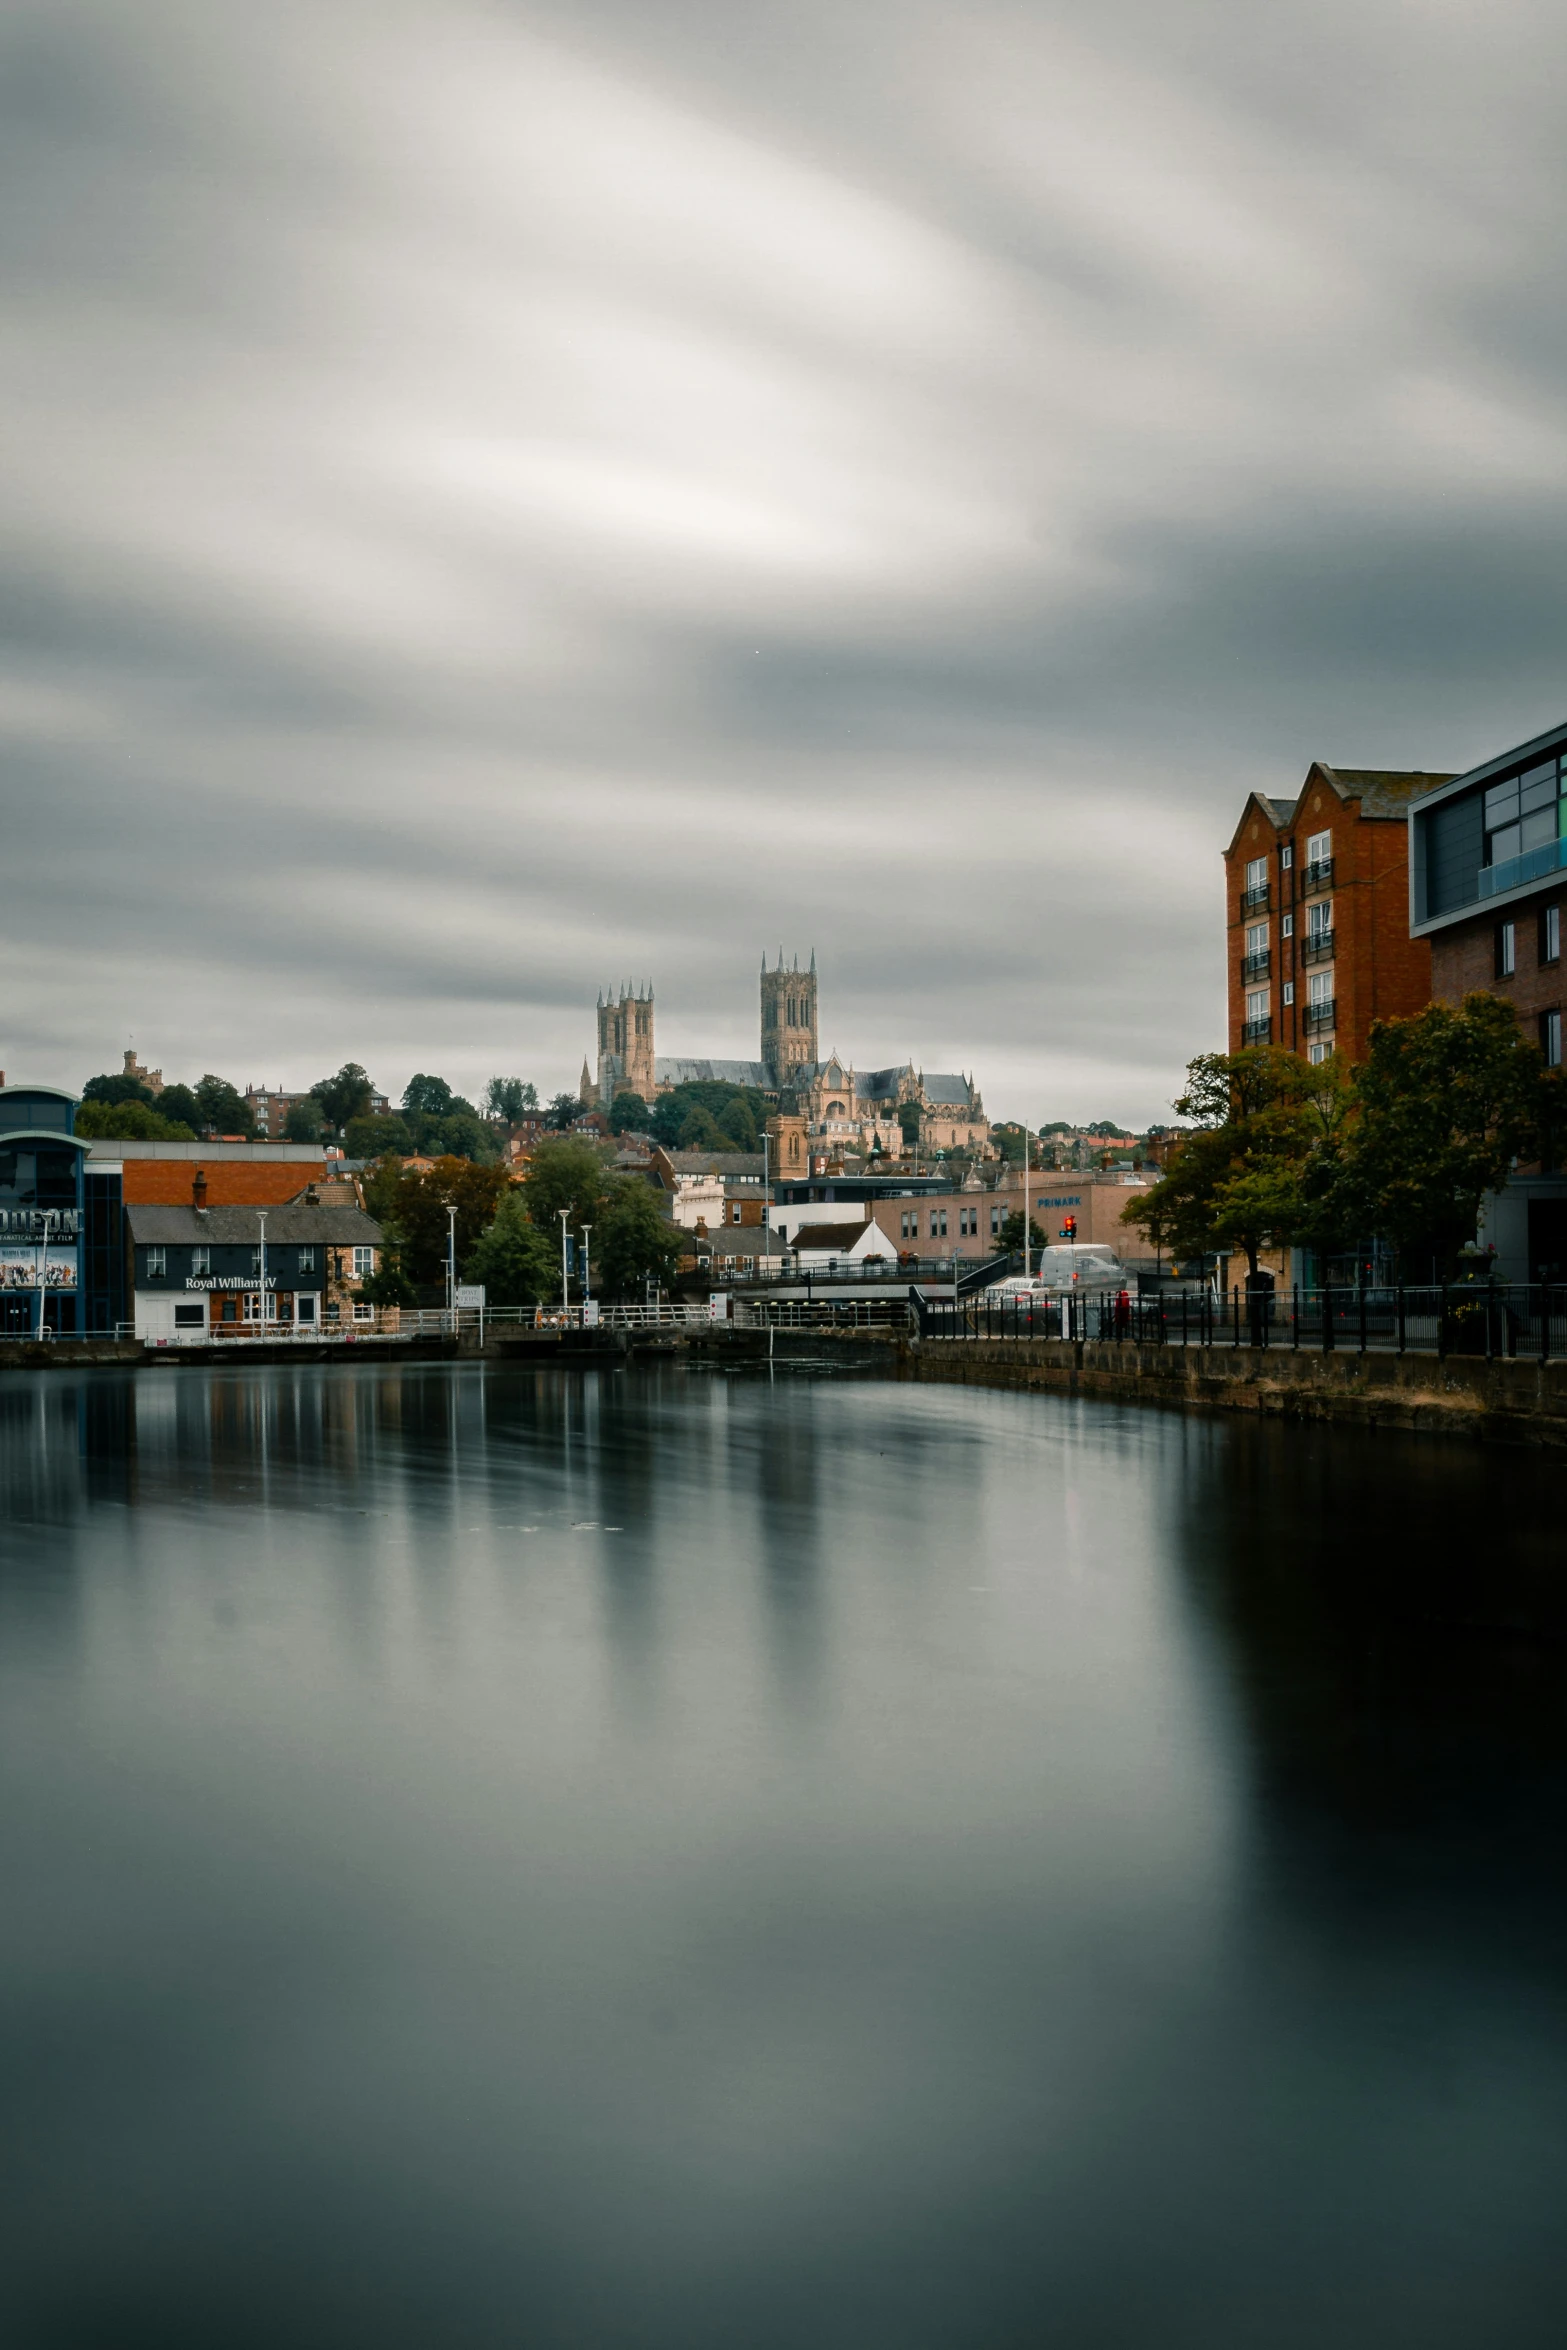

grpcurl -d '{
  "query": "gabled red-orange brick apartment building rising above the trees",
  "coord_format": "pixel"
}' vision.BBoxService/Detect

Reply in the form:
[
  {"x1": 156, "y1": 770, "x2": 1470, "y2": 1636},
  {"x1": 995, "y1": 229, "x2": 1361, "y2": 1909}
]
[{"x1": 1224, "y1": 759, "x2": 1450, "y2": 1060}]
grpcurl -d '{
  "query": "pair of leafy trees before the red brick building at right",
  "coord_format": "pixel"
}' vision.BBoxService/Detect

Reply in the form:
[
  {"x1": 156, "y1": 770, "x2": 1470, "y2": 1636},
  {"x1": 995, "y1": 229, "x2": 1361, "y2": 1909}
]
[{"x1": 1123, "y1": 994, "x2": 1567, "y2": 1281}]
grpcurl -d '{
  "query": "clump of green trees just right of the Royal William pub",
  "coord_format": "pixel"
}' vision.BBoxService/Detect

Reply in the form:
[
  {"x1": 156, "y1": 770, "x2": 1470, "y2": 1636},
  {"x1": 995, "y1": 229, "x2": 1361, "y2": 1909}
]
[{"x1": 364, "y1": 1135, "x2": 691, "y2": 1307}]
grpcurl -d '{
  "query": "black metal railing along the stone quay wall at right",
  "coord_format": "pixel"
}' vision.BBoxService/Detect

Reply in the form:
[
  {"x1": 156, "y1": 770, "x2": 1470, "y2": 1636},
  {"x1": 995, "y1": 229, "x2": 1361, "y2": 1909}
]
[{"x1": 909, "y1": 1283, "x2": 1567, "y2": 1363}]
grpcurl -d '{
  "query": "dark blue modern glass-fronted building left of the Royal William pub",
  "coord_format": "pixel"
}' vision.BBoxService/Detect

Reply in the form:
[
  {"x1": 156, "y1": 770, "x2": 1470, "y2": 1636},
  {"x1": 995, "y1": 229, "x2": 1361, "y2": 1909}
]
[{"x1": 0, "y1": 1086, "x2": 125, "y2": 1337}]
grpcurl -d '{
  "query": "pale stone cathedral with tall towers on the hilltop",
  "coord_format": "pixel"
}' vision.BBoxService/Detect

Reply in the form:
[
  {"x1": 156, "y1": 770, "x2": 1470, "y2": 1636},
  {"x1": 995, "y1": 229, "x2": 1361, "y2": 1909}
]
[{"x1": 580, "y1": 947, "x2": 989, "y2": 1154}]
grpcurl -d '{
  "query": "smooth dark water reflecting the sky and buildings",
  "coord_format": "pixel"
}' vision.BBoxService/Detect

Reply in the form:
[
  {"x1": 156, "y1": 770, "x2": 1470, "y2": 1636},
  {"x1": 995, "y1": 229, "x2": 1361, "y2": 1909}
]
[{"x1": 0, "y1": 1365, "x2": 1567, "y2": 2350}]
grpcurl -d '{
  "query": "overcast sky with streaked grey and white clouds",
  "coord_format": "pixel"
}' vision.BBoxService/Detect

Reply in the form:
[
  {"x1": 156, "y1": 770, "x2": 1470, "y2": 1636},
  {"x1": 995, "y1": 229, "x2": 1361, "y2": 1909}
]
[{"x1": 0, "y1": 0, "x2": 1567, "y2": 1123}]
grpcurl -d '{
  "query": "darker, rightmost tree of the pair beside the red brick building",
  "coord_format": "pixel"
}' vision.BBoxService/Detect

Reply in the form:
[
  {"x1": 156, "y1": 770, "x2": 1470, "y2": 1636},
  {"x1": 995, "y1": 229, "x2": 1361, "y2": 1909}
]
[{"x1": 1330, "y1": 994, "x2": 1560, "y2": 1269}]
